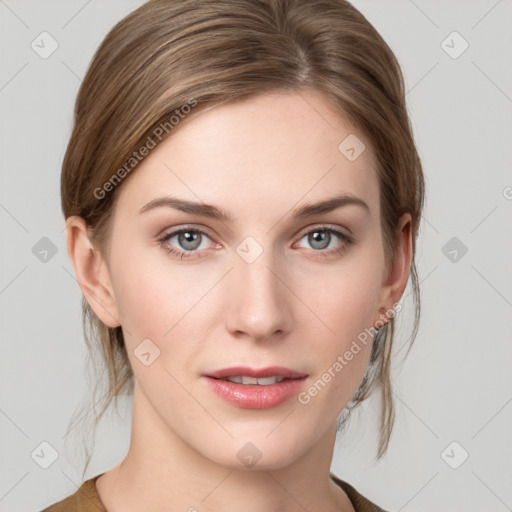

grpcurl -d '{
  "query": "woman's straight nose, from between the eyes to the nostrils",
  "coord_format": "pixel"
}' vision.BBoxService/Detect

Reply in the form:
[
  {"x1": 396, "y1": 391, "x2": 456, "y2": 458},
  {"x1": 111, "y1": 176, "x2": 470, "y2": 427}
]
[{"x1": 227, "y1": 246, "x2": 293, "y2": 341}]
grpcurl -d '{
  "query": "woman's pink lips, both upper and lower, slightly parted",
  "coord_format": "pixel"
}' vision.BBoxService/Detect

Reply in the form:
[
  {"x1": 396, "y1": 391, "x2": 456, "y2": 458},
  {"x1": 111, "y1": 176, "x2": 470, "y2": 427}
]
[{"x1": 203, "y1": 366, "x2": 307, "y2": 409}]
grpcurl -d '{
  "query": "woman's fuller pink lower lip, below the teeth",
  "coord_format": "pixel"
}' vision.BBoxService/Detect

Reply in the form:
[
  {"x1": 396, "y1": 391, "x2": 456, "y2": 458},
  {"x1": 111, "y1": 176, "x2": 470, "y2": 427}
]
[{"x1": 205, "y1": 377, "x2": 306, "y2": 409}]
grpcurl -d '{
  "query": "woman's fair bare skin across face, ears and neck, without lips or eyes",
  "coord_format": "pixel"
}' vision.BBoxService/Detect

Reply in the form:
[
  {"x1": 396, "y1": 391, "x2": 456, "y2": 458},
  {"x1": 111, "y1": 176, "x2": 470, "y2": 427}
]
[{"x1": 67, "y1": 90, "x2": 411, "y2": 512}]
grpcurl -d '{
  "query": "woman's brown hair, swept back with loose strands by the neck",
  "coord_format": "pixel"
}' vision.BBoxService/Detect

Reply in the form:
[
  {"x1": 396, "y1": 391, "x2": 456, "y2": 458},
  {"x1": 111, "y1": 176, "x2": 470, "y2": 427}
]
[{"x1": 61, "y1": 0, "x2": 424, "y2": 473}]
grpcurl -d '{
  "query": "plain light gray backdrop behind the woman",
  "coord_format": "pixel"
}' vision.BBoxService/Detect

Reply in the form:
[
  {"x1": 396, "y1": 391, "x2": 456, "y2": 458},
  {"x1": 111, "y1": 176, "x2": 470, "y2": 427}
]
[{"x1": 0, "y1": 0, "x2": 512, "y2": 512}]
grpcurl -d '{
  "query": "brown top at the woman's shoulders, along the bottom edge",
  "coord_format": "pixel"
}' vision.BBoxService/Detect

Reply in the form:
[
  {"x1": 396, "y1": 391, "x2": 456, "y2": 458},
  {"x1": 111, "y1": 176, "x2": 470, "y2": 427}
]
[{"x1": 42, "y1": 473, "x2": 385, "y2": 512}]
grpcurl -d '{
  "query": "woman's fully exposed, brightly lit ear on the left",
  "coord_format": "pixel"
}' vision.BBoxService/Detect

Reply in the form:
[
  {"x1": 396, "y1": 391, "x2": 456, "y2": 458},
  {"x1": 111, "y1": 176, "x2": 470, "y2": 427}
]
[{"x1": 66, "y1": 215, "x2": 121, "y2": 327}]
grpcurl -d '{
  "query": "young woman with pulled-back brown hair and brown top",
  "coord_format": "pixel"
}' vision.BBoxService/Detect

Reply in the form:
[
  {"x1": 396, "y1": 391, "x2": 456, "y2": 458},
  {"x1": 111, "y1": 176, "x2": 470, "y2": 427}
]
[{"x1": 42, "y1": 0, "x2": 423, "y2": 512}]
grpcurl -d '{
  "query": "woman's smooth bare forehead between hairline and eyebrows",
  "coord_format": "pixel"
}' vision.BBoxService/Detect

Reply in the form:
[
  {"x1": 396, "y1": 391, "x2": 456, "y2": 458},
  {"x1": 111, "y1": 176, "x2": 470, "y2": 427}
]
[{"x1": 118, "y1": 91, "x2": 379, "y2": 217}]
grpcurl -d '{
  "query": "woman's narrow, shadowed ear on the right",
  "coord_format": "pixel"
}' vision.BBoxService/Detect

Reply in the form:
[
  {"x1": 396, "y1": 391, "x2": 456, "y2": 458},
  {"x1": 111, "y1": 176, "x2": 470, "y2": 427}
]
[{"x1": 374, "y1": 213, "x2": 412, "y2": 327}]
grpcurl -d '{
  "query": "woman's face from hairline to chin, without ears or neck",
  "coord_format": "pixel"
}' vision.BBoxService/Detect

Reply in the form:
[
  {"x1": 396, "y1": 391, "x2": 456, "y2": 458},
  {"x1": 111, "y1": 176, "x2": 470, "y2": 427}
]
[{"x1": 91, "y1": 91, "x2": 400, "y2": 469}]
